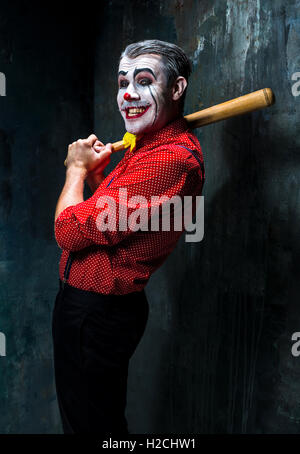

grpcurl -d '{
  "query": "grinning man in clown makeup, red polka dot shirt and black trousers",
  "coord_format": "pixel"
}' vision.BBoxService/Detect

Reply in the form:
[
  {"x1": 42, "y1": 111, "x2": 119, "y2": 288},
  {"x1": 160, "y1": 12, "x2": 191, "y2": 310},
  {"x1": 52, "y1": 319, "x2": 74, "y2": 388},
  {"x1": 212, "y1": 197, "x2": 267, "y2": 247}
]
[{"x1": 52, "y1": 40, "x2": 204, "y2": 434}]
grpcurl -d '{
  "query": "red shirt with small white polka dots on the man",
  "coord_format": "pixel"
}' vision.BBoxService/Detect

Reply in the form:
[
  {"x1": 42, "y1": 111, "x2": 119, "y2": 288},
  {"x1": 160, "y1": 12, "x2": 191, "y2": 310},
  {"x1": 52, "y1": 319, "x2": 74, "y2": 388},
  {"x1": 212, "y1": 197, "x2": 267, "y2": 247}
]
[{"x1": 55, "y1": 117, "x2": 205, "y2": 295}]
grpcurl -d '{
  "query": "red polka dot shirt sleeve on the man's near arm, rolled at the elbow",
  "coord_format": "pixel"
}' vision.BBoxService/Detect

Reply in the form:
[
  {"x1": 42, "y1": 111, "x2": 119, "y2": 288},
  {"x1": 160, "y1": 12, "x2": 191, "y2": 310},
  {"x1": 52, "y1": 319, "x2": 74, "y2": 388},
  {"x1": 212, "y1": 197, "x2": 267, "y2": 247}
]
[{"x1": 55, "y1": 149, "x2": 199, "y2": 251}]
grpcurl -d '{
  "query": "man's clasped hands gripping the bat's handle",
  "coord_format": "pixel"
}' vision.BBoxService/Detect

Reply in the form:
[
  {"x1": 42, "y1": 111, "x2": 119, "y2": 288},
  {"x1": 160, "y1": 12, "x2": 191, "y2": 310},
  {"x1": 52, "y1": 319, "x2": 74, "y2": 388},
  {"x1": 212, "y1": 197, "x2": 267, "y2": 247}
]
[{"x1": 66, "y1": 134, "x2": 112, "y2": 176}]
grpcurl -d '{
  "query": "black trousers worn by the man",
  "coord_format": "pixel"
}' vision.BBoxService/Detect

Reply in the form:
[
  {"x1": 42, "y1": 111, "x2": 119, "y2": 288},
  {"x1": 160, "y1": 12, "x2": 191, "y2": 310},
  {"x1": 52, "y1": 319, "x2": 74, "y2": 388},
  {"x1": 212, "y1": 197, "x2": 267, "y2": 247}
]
[{"x1": 52, "y1": 282, "x2": 149, "y2": 435}]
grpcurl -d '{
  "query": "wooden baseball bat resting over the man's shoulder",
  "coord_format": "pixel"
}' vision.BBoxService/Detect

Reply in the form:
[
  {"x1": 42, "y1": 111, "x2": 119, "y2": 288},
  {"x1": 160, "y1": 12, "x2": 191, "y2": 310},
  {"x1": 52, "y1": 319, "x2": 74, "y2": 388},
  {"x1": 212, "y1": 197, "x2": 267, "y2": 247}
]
[{"x1": 112, "y1": 88, "x2": 275, "y2": 152}]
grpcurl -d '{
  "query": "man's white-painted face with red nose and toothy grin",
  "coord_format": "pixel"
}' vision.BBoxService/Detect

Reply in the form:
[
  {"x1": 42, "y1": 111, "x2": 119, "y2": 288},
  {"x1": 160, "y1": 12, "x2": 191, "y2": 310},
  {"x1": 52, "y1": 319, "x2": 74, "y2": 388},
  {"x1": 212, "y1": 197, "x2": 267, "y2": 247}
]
[{"x1": 117, "y1": 54, "x2": 174, "y2": 134}]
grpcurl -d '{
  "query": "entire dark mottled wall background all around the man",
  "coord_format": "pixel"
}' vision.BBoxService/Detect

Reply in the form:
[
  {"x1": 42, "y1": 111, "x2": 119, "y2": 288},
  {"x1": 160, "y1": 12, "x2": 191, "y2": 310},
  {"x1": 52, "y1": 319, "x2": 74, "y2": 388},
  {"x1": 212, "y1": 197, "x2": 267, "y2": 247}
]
[{"x1": 0, "y1": 0, "x2": 300, "y2": 434}]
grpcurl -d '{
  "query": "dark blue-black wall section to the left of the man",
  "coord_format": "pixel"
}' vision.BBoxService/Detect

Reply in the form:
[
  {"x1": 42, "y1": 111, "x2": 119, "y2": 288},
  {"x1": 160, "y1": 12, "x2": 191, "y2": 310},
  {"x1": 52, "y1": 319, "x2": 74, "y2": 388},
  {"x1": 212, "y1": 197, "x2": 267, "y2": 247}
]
[{"x1": 0, "y1": 2, "x2": 94, "y2": 433}]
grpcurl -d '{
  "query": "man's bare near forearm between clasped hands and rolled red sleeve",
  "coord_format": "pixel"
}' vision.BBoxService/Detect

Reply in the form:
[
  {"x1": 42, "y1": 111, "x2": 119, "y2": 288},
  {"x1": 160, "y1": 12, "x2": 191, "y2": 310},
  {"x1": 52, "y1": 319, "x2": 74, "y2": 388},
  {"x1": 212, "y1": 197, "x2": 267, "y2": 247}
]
[{"x1": 55, "y1": 166, "x2": 87, "y2": 221}]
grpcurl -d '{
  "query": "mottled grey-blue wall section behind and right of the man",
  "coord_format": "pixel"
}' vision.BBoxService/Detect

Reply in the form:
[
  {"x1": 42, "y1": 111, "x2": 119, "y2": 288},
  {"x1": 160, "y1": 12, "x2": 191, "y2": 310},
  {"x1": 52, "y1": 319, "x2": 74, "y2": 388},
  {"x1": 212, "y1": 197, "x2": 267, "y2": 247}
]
[{"x1": 95, "y1": 0, "x2": 300, "y2": 433}]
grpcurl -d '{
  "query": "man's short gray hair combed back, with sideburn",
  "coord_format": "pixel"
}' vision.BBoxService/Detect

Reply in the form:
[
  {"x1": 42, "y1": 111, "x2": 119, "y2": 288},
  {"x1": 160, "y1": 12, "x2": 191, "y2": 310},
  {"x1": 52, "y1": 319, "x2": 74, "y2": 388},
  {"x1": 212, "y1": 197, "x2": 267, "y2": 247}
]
[{"x1": 120, "y1": 39, "x2": 192, "y2": 107}]
